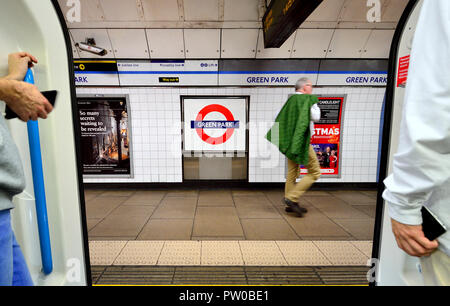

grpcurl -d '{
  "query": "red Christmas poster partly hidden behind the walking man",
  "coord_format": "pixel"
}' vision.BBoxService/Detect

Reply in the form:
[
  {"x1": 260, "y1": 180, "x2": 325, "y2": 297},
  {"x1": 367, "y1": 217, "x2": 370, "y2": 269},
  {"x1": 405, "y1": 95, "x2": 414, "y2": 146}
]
[{"x1": 300, "y1": 96, "x2": 346, "y2": 177}]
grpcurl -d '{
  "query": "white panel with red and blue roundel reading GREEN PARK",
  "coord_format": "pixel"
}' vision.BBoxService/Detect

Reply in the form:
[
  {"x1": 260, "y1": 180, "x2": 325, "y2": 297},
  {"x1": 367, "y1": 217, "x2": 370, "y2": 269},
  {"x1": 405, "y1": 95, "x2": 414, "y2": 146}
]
[{"x1": 182, "y1": 97, "x2": 247, "y2": 152}]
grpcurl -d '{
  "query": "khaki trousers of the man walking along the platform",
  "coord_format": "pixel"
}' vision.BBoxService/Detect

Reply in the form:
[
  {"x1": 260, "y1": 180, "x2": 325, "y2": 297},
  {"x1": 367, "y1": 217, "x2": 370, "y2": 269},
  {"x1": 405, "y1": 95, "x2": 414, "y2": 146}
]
[{"x1": 284, "y1": 145, "x2": 320, "y2": 202}]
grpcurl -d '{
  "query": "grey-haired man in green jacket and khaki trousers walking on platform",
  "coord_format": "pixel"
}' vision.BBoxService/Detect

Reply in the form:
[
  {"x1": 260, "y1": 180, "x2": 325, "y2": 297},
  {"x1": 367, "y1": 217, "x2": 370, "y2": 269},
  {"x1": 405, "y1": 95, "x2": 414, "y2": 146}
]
[{"x1": 266, "y1": 78, "x2": 320, "y2": 217}]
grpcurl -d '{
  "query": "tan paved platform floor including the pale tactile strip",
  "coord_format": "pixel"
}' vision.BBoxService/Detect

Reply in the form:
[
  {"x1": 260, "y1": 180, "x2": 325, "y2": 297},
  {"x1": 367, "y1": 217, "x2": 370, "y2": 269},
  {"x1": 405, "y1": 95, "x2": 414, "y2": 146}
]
[{"x1": 85, "y1": 188, "x2": 376, "y2": 284}]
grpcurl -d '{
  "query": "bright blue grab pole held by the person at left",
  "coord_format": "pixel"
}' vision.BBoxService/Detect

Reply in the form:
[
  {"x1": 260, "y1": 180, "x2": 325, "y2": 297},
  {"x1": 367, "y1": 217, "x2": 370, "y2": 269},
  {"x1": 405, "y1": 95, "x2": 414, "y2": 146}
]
[{"x1": 24, "y1": 69, "x2": 53, "y2": 275}]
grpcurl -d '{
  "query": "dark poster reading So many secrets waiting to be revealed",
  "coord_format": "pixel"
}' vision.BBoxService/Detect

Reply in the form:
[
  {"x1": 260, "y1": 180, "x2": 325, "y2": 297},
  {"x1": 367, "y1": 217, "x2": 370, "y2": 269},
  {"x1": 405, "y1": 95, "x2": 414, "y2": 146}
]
[{"x1": 78, "y1": 96, "x2": 132, "y2": 177}]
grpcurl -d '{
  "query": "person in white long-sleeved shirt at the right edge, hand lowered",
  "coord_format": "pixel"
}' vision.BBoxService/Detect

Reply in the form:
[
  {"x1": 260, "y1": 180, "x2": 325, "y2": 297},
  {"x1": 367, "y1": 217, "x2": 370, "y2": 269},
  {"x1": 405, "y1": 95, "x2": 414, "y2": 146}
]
[{"x1": 383, "y1": 0, "x2": 450, "y2": 285}]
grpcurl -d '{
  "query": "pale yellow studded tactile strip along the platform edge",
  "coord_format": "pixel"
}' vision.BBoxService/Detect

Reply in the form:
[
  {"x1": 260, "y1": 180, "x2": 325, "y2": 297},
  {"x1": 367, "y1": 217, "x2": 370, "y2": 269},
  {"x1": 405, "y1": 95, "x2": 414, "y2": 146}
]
[{"x1": 89, "y1": 240, "x2": 372, "y2": 266}]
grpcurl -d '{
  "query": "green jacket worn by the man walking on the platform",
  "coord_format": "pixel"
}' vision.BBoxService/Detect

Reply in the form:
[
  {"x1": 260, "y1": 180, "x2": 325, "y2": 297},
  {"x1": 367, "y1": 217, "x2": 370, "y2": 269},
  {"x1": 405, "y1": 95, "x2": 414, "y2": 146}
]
[{"x1": 266, "y1": 94, "x2": 319, "y2": 165}]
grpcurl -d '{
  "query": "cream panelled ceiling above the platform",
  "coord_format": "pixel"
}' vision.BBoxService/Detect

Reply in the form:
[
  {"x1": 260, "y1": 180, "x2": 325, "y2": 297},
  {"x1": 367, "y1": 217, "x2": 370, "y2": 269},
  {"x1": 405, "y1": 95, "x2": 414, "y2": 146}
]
[{"x1": 58, "y1": 0, "x2": 408, "y2": 58}]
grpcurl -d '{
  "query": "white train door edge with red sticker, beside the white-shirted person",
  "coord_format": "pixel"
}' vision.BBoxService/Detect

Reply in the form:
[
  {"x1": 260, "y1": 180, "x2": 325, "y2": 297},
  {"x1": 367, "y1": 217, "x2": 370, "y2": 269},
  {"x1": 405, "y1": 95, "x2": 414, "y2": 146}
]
[{"x1": 368, "y1": 0, "x2": 423, "y2": 286}]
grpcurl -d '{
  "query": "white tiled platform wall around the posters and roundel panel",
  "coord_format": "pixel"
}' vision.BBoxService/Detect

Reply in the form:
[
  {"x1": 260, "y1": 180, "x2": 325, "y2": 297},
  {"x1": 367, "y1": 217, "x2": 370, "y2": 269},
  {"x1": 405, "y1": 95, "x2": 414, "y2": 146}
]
[{"x1": 77, "y1": 87, "x2": 385, "y2": 183}]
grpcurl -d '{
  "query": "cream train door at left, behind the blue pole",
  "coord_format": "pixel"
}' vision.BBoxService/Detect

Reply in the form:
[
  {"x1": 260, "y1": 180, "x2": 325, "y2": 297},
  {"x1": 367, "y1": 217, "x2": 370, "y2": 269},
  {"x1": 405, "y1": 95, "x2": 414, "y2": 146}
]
[{"x1": 0, "y1": 0, "x2": 91, "y2": 286}]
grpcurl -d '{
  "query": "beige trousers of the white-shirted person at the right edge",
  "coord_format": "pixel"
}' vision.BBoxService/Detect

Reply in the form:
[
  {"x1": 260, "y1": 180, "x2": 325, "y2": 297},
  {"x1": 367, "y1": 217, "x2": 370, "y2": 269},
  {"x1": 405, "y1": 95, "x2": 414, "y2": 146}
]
[{"x1": 420, "y1": 250, "x2": 450, "y2": 286}]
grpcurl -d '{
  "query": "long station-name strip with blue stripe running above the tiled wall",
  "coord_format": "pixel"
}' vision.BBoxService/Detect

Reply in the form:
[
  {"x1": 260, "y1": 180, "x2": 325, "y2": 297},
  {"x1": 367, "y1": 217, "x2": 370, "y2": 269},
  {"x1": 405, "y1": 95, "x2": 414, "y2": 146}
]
[{"x1": 74, "y1": 59, "x2": 386, "y2": 87}]
